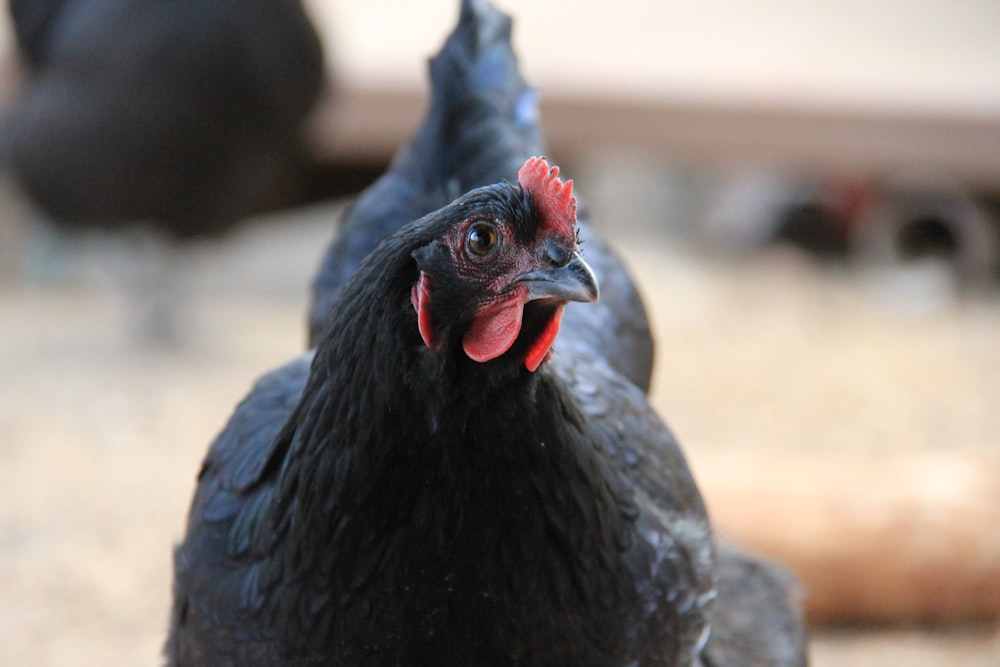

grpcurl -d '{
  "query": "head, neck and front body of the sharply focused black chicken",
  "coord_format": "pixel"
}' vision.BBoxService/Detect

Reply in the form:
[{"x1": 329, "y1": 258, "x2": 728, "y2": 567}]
[{"x1": 167, "y1": 159, "x2": 715, "y2": 666}]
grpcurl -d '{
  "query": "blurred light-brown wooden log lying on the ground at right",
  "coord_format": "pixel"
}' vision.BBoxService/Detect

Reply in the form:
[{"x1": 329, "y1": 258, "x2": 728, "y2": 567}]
[{"x1": 694, "y1": 452, "x2": 1000, "y2": 623}]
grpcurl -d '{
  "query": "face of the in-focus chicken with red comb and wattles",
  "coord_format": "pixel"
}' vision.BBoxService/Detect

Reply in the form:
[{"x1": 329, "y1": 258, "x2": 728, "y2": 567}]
[{"x1": 411, "y1": 158, "x2": 598, "y2": 371}]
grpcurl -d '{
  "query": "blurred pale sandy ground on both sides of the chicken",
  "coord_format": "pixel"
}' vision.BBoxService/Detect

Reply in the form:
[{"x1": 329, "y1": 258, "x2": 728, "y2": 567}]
[{"x1": 0, "y1": 192, "x2": 1000, "y2": 667}]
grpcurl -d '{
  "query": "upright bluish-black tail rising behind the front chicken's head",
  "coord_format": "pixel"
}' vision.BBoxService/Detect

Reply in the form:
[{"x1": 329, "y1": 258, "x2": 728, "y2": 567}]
[{"x1": 310, "y1": 0, "x2": 543, "y2": 345}]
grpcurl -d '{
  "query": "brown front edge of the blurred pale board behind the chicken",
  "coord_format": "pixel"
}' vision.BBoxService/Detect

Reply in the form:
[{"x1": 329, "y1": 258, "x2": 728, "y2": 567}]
[{"x1": 312, "y1": 86, "x2": 1000, "y2": 188}]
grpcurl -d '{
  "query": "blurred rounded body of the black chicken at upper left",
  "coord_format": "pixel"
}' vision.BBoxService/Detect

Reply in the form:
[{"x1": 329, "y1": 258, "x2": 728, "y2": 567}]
[{"x1": 2, "y1": 0, "x2": 323, "y2": 237}]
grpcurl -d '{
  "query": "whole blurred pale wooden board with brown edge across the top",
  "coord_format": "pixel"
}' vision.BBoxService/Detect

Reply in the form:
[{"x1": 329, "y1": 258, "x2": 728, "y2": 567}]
[{"x1": 300, "y1": 0, "x2": 1000, "y2": 188}]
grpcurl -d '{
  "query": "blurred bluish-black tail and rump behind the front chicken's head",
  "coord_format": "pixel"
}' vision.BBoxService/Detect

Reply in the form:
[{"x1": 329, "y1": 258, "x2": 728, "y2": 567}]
[{"x1": 309, "y1": 0, "x2": 653, "y2": 389}]
